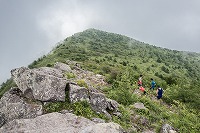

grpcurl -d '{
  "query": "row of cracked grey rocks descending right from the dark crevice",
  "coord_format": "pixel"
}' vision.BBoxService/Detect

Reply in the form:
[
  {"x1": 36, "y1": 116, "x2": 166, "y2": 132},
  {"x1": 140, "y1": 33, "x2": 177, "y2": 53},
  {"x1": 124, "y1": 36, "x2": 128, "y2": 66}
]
[{"x1": 67, "y1": 83, "x2": 121, "y2": 118}]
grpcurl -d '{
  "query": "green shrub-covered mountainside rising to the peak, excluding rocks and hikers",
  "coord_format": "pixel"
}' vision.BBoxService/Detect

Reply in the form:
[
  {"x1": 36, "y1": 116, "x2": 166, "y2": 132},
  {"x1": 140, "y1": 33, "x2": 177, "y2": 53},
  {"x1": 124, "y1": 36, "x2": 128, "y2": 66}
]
[{"x1": 0, "y1": 29, "x2": 200, "y2": 132}]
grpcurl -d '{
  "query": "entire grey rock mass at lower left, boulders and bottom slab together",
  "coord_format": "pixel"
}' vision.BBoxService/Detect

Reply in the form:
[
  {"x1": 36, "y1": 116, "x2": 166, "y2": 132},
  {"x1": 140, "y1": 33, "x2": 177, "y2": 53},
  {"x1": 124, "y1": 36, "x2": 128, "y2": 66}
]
[{"x1": 0, "y1": 62, "x2": 175, "y2": 133}]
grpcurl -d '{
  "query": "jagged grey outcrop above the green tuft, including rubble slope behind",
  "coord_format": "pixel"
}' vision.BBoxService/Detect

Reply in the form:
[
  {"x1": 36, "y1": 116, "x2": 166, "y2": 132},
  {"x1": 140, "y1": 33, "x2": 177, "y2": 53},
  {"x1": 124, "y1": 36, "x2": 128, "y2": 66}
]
[{"x1": 11, "y1": 63, "x2": 120, "y2": 117}]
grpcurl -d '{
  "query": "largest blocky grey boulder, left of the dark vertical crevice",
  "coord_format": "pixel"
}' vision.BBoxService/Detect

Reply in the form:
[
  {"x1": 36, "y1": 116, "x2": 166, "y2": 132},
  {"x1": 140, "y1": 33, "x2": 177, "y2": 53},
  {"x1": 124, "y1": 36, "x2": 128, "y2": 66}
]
[{"x1": 11, "y1": 67, "x2": 66, "y2": 101}]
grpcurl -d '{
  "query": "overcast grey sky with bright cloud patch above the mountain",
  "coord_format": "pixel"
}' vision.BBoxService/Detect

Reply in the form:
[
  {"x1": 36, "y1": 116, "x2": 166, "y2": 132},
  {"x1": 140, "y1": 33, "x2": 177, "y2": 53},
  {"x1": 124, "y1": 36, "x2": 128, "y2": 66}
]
[{"x1": 0, "y1": 0, "x2": 200, "y2": 84}]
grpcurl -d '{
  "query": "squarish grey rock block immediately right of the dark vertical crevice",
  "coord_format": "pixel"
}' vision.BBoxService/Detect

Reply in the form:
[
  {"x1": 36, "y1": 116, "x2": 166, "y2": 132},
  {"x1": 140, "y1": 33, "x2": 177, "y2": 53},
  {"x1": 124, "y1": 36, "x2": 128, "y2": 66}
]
[{"x1": 69, "y1": 83, "x2": 89, "y2": 103}]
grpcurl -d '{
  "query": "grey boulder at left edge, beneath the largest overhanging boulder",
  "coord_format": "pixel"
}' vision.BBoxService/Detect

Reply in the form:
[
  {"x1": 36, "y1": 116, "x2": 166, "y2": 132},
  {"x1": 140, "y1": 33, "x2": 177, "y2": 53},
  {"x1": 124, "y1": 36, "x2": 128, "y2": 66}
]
[{"x1": 0, "y1": 88, "x2": 43, "y2": 126}]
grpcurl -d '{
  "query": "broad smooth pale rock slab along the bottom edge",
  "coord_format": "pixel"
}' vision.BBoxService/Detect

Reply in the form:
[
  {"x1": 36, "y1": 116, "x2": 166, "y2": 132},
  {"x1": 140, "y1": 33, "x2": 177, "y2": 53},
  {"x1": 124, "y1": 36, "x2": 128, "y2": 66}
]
[{"x1": 0, "y1": 112, "x2": 123, "y2": 133}]
